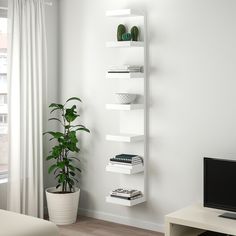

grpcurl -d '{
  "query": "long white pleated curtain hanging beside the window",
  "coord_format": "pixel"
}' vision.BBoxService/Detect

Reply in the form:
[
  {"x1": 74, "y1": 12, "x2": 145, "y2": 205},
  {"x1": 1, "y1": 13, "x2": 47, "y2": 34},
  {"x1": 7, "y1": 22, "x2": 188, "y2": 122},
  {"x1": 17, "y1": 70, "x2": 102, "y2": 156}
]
[{"x1": 8, "y1": 0, "x2": 46, "y2": 218}]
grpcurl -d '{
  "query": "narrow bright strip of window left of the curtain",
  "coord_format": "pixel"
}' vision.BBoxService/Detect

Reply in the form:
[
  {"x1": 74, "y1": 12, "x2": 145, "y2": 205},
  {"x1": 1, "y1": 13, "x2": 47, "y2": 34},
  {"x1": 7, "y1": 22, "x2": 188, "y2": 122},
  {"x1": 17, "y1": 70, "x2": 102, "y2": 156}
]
[{"x1": 0, "y1": 15, "x2": 8, "y2": 179}]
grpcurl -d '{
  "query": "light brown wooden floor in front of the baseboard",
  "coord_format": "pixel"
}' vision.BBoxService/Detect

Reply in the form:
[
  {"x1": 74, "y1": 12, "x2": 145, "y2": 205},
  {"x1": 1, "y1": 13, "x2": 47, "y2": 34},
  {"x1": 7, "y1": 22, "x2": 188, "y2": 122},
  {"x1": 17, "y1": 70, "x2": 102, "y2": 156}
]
[{"x1": 59, "y1": 216, "x2": 164, "y2": 236}]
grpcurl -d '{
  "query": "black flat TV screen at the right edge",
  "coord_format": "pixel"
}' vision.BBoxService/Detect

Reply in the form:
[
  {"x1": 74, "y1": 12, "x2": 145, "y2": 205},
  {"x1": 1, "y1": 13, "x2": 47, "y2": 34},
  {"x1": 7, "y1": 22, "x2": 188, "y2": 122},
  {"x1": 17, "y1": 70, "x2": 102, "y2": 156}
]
[{"x1": 204, "y1": 157, "x2": 236, "y2": 212}]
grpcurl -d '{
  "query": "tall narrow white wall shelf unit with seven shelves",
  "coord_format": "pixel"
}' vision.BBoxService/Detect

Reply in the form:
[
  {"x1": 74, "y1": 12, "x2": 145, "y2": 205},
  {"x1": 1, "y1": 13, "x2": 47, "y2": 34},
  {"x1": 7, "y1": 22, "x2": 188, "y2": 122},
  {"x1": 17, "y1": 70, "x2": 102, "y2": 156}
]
[{"x1": 106, "y1": 9, "x2": 148, "y2": 207}]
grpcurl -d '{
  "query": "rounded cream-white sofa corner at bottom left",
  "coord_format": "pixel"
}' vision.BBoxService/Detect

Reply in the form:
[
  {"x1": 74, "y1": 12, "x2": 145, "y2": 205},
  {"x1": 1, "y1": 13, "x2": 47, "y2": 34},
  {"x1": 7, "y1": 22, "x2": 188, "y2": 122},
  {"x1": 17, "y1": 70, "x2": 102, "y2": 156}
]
[{"x1": 0, "y1": 210, "x2": 59, "y2": 236}]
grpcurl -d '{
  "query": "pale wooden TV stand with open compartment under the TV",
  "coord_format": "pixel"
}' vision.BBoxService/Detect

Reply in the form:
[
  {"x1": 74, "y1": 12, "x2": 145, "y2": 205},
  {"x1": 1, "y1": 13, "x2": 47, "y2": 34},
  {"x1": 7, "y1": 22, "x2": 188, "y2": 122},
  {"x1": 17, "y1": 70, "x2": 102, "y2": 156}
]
[{"x1": 165, "y1": 204, "x2": 236, "y2": 236}]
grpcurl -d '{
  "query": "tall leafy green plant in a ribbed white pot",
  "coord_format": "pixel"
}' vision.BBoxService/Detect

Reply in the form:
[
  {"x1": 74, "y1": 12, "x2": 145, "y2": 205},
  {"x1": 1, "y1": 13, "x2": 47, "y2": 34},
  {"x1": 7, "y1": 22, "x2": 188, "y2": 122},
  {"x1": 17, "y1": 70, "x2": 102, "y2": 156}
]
[{"x1": 44, "y1": 97, "x2": 90, "y2": 225}]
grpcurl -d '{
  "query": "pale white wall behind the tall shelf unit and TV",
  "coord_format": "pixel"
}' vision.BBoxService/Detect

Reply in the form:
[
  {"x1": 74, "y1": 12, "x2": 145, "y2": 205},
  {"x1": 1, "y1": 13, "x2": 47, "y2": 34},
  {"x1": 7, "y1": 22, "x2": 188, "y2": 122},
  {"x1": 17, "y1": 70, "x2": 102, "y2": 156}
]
[{"x1": 59, "y1": 0, "x2": 236, "y2": 230}]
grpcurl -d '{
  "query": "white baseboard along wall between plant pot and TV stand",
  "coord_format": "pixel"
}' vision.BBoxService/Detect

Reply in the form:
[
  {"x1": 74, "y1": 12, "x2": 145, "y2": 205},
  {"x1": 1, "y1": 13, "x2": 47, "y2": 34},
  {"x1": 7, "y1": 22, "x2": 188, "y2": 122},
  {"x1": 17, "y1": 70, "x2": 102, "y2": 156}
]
[{"x1": 79, "y1": 208, "x2": 164, "y2": 233}]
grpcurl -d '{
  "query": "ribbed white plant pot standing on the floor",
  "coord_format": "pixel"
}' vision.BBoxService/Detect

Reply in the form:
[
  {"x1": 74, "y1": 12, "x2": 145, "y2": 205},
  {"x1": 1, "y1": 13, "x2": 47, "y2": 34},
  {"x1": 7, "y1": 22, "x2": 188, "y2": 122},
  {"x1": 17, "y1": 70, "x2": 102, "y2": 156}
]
[{"x1": 46, "y1": 187, "x2": 80, "y2": 225}]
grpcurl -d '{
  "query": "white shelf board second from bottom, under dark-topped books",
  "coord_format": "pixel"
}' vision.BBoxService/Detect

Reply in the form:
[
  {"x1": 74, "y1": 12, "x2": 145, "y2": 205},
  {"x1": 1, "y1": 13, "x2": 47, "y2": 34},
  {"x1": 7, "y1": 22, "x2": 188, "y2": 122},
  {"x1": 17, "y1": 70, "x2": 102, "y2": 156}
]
[{"x1": 106, "y1": 164, "x2": 144, "y2": 175}]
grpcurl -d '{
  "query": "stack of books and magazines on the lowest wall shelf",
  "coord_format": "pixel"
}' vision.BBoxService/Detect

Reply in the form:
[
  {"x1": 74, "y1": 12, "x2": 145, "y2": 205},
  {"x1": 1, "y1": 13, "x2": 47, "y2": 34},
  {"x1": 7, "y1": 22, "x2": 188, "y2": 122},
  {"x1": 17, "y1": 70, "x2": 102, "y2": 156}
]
[{"x1": 110, "y1": 188, "x2": 143, "y2": 200}]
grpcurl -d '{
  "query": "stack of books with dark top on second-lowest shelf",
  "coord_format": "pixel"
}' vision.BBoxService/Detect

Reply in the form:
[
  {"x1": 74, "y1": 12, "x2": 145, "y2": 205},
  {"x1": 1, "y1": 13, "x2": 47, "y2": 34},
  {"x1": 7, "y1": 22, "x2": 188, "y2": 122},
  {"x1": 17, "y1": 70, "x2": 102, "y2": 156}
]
[{"x1": 109, "y1": 154, "x2": 143, "y2": 168}]
